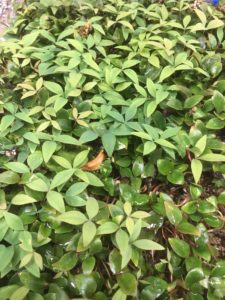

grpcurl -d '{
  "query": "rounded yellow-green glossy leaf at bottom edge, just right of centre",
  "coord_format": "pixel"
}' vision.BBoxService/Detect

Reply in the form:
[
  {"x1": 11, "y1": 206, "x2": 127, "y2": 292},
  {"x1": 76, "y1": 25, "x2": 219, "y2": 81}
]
[{"x1": 117, "y1": 273, "x2": 138, "y2": 296}]
